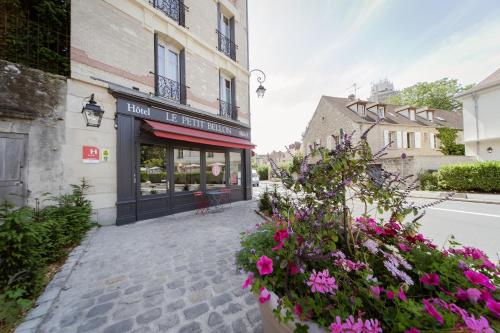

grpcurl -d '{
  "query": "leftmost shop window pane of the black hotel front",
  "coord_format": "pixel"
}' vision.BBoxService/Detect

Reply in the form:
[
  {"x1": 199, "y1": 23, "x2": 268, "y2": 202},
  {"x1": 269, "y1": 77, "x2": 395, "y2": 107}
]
[{"x1": 140, "y1": 144, "x2": 168, "y2": 195}]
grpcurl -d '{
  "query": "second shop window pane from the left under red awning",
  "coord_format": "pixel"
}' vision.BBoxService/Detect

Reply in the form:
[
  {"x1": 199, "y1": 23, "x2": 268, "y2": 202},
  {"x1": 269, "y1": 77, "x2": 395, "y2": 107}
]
[{"x1": 174, "y1": 148, "x2": 201, "y2": 192}]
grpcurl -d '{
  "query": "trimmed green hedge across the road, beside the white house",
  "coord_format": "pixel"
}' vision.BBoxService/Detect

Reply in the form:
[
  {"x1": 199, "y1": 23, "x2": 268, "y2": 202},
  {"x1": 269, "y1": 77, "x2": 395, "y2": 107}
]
[{"x1": 438, "y1": 161, "x2": 500, "y2": 192}]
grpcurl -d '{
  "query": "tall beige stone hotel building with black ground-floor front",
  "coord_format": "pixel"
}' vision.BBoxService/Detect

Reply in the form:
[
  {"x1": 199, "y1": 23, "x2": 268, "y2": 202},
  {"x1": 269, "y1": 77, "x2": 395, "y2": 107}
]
[{"x1": 0, "y1": 0, "x2": 254, "y2": 224}]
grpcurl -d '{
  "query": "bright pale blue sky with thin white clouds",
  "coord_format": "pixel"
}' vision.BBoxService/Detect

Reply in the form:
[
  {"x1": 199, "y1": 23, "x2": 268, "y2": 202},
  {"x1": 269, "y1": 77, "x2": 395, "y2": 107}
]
[{"x1": 248, "y1": 0, "x2": 500, "y2": 153}]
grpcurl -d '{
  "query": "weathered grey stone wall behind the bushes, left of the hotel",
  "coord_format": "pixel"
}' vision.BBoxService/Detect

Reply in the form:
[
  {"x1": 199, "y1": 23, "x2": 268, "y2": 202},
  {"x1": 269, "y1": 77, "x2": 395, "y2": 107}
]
[{"x1": 0, "y1": 60, "x2": 67, "y2": 204}]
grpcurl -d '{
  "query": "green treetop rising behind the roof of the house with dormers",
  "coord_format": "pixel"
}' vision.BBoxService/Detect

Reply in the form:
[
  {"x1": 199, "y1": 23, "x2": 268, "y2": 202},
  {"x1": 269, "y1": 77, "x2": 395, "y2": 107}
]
[{"x1": 388, "y1": 78, "x2": 473, "y2": 111}]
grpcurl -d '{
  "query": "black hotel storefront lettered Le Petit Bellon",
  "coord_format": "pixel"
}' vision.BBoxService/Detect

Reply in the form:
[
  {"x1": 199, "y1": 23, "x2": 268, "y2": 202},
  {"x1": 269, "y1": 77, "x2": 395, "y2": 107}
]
[{"x1": 110, "y1": 87, "x2": 253, "y2": 225}]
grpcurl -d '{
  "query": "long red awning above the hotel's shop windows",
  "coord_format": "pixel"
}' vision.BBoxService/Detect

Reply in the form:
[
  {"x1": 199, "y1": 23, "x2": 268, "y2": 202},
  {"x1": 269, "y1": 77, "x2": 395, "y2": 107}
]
[{"x1": 144, "y1": 120, "x2": 255, "y2": 149}]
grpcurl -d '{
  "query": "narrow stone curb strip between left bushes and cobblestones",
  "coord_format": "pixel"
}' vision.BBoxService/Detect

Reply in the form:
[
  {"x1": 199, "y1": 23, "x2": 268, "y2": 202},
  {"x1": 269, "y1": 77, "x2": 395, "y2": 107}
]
[{"x1": 14, "y1": 227, "x2": 98, "y2": 333}]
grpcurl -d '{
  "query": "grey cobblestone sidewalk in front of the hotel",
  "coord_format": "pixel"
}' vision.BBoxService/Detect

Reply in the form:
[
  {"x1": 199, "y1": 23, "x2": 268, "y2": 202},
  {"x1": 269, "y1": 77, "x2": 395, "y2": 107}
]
[{"x1": 37, "y1": 202, "x2": 262, "y2": 333}]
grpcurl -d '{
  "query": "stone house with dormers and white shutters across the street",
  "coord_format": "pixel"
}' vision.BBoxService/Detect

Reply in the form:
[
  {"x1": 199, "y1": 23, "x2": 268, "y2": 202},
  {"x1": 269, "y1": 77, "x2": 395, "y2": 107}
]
[{"x1": 303, "y1": 96, "x2": 462, "y2": 158}]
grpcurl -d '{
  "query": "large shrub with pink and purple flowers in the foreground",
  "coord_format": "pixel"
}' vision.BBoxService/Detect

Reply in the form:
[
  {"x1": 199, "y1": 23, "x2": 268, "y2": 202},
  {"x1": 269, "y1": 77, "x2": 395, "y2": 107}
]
[{"x1": 237, "y1": 129, "x2": 500, "y2": 333}]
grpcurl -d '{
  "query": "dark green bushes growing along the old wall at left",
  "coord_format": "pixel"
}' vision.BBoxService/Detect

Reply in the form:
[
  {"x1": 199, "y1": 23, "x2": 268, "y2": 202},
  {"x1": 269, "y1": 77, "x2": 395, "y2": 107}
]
[{"x1": 0, "y1": 179, "x2": 92, "y2": 332}]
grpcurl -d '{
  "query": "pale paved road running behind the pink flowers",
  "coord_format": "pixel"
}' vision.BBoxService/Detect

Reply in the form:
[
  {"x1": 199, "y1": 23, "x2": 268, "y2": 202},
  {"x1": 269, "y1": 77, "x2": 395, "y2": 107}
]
[{"x1": 254, "y1": 182, "x2": 500, "y2": 260}]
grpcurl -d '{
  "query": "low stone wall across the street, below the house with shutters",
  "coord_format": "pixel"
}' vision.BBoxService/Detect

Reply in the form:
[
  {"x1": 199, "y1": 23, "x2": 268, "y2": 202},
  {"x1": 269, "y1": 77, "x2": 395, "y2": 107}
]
[{"x1": 380, "y1": 155, "x2": 476, "y2": 177}]
